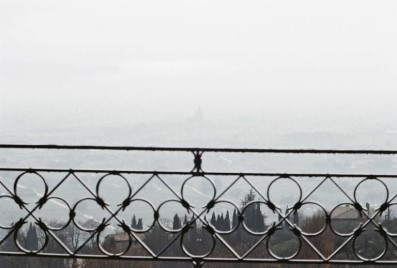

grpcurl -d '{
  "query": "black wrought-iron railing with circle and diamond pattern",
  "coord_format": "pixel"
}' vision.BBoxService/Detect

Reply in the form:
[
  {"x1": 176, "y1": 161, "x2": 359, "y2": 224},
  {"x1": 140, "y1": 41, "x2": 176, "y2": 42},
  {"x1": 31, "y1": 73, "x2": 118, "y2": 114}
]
[{"x1": 0, "y1": 145, "x2": 397, "y2": 267}]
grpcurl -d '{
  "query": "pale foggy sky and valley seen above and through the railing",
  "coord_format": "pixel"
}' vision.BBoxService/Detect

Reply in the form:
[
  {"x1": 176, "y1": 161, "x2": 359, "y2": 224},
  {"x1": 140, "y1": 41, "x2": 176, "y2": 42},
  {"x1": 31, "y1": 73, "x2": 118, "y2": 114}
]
[{"x1": 0, "y1": 0, "x2": 397, "y2": 267}]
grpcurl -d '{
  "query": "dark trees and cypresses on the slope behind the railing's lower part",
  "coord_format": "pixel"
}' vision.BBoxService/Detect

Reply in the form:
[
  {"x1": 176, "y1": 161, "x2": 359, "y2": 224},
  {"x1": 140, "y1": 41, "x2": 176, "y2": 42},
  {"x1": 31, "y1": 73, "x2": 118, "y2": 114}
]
[{"x1": 0, "y1": 189, "x2": 397, "y2": 268}]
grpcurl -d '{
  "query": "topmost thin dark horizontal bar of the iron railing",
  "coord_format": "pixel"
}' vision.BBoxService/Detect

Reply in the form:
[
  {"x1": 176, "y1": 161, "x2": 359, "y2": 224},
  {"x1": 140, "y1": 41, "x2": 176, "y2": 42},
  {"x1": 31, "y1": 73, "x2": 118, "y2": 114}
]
[{"x1": 0, "y1": 144, "x2": 397, "y2": 155}]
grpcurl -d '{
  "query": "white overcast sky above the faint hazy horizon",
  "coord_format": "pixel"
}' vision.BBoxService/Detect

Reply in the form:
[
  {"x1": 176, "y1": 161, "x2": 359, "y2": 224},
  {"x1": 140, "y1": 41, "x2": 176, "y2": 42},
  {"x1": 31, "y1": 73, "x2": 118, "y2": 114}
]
[{"x1": 0, "y1": 0, "x2": 397, "y2": 140}]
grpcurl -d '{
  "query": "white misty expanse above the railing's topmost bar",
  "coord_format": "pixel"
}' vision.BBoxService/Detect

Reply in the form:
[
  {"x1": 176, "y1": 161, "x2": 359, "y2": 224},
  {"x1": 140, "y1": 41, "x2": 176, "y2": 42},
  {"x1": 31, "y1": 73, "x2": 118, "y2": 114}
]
[{"x1": 0, "y1": 0, "x2": 397, "y2": 149}]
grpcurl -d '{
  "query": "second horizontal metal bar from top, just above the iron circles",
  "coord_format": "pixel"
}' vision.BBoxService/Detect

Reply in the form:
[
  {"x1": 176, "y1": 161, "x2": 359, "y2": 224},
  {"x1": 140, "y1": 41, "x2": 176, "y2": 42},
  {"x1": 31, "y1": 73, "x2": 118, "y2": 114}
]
[{"x1": 0, "y1": 167, "x2": 397, "y2": 178}]
